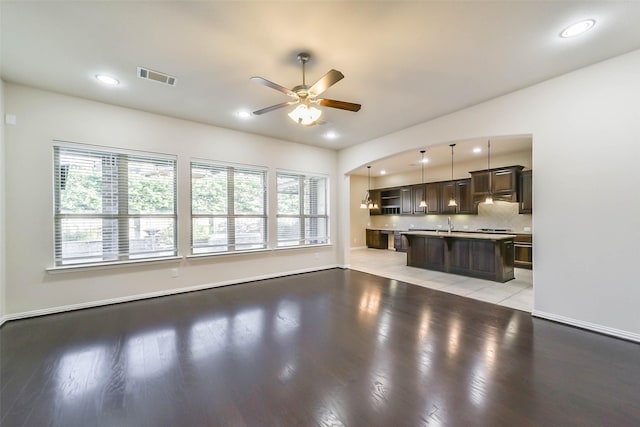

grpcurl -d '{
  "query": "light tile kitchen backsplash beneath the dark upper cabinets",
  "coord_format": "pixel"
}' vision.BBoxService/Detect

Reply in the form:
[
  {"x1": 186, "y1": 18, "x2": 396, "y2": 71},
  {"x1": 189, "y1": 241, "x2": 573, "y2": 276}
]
[{"x1": 368, "y1": 201, "x2": 533, "y2": 233}]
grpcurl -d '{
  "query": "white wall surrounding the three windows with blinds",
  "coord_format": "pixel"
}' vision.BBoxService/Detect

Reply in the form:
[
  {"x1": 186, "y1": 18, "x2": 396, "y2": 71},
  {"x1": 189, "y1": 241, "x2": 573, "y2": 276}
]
[{"x1": 3, "y1": 83, "x2": 342, "y2": 317}]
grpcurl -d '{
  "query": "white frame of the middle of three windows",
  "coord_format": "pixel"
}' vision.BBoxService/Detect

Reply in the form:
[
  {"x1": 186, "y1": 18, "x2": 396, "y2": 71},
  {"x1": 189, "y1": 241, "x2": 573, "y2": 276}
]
[{"x1": 189, "y1": 159, "x2": 269, "y2": 257}]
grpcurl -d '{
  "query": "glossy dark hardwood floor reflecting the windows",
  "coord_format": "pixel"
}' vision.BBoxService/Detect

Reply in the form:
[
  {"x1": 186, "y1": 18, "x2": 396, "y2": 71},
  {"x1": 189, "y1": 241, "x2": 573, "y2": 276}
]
[{"x1": 0, "y1": 269, "x2": 640, "y2": 427}]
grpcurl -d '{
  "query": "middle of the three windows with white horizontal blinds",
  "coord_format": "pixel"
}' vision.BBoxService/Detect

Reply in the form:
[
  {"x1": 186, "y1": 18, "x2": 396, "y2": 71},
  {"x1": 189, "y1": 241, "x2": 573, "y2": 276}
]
[{"x1": 191, "y1": 161, "x2": 267, "y2": 255}]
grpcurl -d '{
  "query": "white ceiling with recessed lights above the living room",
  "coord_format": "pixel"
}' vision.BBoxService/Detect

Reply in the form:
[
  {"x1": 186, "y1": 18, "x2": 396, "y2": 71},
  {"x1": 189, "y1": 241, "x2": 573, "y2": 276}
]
[{"x1": 0, "y1": 0, "x2": 640, "y2": 157}]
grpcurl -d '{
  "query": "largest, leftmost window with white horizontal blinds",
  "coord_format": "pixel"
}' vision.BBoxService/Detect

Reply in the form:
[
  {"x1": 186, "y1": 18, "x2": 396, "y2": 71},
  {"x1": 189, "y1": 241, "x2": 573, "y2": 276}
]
[{"x1": 54, "y1": 145, "x2": 177, "y2": 265}]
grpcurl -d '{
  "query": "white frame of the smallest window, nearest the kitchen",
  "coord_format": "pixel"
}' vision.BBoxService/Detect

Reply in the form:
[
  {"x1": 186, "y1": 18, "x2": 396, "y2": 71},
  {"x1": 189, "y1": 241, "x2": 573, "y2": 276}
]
[{"x1": 276, "y1": 170, "x2": 331, "y2": 249}]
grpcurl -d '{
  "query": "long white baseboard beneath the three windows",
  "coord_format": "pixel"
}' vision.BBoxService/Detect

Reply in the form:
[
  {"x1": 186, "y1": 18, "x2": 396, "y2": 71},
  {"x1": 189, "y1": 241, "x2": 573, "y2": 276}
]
[{"x1": 0, "y1": 264, "x2": 341, "y2": 326}]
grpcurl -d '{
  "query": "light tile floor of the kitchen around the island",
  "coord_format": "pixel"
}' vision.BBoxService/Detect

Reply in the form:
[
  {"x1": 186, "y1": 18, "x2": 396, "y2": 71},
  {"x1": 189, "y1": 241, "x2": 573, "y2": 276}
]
[{"x1": 349, "y1": 248, "x2": 533, "y2": 312}]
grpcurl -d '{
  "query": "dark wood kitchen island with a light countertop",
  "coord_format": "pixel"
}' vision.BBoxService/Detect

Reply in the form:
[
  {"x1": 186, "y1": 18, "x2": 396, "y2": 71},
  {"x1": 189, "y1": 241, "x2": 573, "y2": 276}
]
[{"x1": 402, "y1": 231, "x2": 516, "y2": 282}]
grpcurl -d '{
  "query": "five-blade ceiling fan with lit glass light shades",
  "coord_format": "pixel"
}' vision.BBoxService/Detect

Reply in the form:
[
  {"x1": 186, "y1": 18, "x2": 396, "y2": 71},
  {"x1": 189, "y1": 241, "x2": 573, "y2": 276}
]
[{"x1": 251, "y1": 52, "x2": 361, "y2": 126}]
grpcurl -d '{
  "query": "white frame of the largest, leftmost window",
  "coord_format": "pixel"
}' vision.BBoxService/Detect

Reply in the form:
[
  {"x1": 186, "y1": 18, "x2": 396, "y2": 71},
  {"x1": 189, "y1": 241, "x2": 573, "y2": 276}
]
[{"x1": 53, "y1": 140, "x2": 178, "y2": 269}]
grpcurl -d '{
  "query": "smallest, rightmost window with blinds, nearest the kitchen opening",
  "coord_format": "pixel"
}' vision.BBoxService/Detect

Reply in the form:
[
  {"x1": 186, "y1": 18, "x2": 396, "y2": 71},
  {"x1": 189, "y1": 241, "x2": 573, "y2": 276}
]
[{"x1": 277, "y1": 172, "x2": 329, "y2": 247}]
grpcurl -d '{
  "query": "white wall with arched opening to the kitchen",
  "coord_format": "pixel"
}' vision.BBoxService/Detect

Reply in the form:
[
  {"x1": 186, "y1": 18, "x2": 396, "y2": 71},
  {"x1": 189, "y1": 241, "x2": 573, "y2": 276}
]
[{"x1": 339, "y1": 51, "x2": 640, "y2": 341}]
